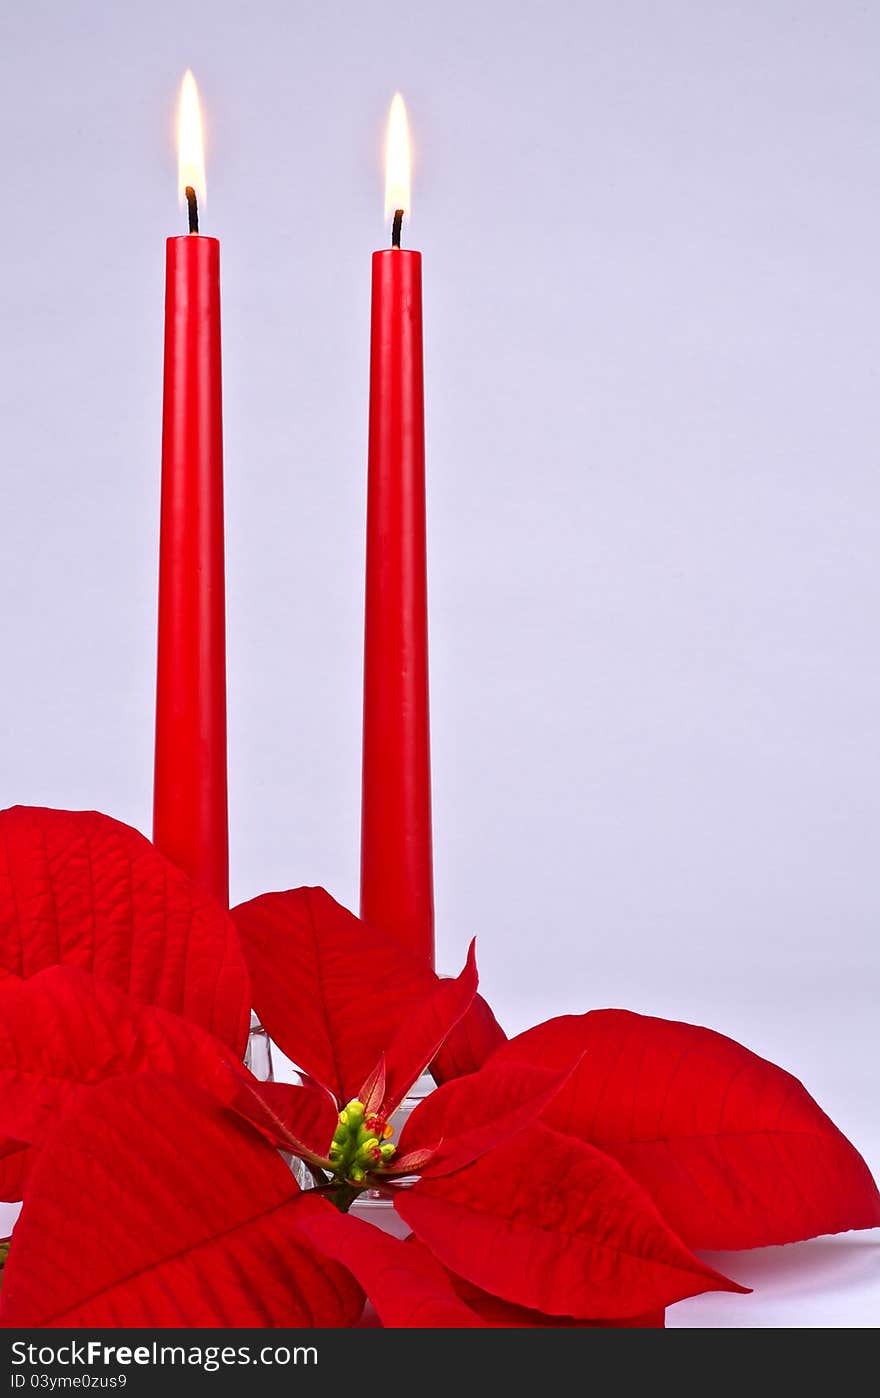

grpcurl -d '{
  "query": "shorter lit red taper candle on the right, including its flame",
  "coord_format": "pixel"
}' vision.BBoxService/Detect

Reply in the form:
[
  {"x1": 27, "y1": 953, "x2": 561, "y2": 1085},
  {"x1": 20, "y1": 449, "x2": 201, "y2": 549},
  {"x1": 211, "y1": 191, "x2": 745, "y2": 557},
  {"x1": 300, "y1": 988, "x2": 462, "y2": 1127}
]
[{"x1": 361, "y1": 98, "x2": 434, "y2": 962}]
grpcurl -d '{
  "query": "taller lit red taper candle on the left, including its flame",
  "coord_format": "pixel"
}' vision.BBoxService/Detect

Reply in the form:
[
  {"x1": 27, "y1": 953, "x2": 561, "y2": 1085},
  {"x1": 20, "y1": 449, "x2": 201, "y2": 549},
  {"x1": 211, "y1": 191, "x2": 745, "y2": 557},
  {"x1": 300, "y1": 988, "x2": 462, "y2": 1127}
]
[{"x1": 152, "y1": 74, "x2": 229, "y2": 906}]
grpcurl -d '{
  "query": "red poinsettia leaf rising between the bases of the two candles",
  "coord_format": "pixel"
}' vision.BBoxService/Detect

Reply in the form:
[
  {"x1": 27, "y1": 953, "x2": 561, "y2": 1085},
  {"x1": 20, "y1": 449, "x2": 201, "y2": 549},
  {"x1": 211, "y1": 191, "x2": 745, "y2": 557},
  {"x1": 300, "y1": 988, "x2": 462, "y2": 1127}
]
[{"x1": 232, "y1": 888, "x2": 438, "y2": 1104}]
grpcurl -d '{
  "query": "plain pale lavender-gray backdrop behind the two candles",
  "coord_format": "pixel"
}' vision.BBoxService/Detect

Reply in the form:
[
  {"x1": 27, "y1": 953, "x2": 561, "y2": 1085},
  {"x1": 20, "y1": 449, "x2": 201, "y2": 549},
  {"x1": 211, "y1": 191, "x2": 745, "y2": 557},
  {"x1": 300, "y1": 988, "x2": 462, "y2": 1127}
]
[{"x1": 0, "y1": 0, "x2": 880, "y2": 1325}]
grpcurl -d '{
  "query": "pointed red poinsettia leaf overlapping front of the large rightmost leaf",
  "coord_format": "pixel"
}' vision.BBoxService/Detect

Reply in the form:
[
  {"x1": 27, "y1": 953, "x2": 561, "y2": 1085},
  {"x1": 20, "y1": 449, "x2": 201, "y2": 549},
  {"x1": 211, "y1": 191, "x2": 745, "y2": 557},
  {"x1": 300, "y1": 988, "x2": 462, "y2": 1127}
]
[{"x1": 395, "y1": 1125, "x2": 746, "y2": 1320}]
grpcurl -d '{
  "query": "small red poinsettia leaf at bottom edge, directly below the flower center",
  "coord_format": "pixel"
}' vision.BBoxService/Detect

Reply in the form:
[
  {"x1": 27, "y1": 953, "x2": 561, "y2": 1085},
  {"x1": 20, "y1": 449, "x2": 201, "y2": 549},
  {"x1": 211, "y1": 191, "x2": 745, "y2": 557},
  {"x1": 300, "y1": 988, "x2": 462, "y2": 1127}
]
[{"x1": 297, "y1": 1194, "x2": 484, "y2": 1329}]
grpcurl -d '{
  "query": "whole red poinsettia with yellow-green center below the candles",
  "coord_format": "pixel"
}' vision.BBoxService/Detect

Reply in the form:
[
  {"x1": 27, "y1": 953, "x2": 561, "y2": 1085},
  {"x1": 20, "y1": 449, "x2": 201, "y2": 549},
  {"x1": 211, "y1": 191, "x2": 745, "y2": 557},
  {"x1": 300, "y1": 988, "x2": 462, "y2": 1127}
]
[{"x1": 0, "y1": 808, "x2": 880, "y2": 1327}]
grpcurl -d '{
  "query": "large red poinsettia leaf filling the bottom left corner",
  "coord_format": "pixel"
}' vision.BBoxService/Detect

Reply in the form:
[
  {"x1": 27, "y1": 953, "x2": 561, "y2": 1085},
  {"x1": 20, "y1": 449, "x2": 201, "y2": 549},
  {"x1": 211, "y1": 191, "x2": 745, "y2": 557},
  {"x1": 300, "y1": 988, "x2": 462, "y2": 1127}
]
[{"x1": 0, "y1": 1074, "x2": 362, "y2": 1328}]
